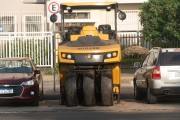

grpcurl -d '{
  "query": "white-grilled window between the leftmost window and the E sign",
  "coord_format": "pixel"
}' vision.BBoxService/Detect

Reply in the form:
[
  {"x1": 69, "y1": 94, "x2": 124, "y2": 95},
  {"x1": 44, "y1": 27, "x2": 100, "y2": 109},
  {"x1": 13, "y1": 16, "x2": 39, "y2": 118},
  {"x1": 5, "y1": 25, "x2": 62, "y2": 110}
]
[{"x1": 24, "y1": 15, "x2": 44, "y2": 32}]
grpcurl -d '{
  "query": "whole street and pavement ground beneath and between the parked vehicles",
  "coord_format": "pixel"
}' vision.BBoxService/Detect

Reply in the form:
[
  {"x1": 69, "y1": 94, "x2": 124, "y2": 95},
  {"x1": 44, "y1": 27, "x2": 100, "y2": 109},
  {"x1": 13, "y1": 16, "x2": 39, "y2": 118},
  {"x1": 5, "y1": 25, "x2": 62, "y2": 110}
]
[{"x1": 0, "y1": 74, "x2": 180, "y2": 120}]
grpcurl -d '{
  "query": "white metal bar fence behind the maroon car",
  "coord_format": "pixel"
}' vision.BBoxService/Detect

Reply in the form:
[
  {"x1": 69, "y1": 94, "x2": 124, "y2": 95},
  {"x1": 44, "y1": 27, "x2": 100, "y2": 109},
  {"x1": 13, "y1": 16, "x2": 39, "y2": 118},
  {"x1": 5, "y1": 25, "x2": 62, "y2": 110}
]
[{"x1": 0, "y1": 32, "x2": 53, "y2": 67}]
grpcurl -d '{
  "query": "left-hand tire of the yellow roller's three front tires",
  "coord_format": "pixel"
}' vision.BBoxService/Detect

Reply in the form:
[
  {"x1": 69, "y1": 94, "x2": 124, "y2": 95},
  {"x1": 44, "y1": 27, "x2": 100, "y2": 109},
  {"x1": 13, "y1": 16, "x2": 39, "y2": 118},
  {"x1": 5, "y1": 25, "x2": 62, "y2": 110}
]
[{"x1": 65, "y1": 73, "x2": 78, "y2": 107}]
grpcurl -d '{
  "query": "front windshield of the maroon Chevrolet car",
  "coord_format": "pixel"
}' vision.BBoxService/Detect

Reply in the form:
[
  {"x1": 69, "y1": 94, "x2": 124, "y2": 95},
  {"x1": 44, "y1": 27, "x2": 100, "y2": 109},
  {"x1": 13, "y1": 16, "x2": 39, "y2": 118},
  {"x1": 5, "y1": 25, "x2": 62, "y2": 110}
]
[{"x1": 0, "y1": 60, "x2": 32, "y2": 73}]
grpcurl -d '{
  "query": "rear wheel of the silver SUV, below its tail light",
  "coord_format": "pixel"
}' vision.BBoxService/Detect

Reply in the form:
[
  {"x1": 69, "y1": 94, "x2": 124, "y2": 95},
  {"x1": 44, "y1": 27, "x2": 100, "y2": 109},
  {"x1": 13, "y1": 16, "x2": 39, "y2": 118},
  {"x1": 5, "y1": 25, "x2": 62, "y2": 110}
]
[{"x1": 147, "y1": 87, "x2": 157, "y2": 104}]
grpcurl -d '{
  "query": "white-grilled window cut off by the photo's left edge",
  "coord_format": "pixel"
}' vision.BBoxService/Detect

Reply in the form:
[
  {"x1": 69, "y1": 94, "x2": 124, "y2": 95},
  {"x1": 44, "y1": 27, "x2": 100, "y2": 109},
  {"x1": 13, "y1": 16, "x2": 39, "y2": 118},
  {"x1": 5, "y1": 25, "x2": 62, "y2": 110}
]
[{"x1": 0, "y1": 13, "x2": 16, "y2": 32}]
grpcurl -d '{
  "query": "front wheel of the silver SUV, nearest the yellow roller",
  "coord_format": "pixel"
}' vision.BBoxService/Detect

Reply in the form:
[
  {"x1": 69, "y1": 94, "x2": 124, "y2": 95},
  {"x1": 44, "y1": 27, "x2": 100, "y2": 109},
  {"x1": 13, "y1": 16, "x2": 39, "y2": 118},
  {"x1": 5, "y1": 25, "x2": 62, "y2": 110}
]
[{"x1": 134, "y1": 82, "x2": 143, "y2": 100}]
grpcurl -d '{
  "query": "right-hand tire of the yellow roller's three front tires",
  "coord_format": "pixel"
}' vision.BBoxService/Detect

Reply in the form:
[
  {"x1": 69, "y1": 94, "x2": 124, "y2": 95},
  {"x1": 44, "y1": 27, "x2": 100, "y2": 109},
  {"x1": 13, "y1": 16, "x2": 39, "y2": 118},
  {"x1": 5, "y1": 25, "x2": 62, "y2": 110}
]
[{"x1": 101, "y1": 72, "x2": 113, "y2": 106}]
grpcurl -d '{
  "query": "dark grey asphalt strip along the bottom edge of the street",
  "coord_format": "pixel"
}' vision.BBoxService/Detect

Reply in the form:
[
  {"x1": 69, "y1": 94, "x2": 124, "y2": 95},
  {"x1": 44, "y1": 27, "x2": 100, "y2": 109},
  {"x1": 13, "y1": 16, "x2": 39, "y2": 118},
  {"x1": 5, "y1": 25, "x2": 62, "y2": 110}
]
[{"x1": 0, "y1": 111, "x2": 180, "y2": 120}]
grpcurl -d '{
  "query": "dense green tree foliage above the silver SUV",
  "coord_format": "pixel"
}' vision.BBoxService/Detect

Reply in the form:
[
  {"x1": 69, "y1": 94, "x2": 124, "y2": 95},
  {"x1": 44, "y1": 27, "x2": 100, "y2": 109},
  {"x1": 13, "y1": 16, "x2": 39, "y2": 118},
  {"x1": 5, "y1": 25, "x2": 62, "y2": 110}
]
[{"x1": 140, "y1": 0, "x2": 180, "y2": 46}]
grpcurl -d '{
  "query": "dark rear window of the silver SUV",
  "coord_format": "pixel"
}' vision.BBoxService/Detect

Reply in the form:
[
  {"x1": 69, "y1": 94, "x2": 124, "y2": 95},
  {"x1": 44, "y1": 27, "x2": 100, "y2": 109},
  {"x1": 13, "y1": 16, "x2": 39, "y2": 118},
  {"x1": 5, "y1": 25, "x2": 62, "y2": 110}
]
[{"x1": 161, "y1": 52, "x2": 180, "y2": 66}]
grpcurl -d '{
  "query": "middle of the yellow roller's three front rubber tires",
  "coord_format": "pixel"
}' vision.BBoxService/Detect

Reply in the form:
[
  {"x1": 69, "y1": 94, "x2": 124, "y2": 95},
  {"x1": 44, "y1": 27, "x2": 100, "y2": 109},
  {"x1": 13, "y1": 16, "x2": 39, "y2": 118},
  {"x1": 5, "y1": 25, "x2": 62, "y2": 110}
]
[{"x1": 83, "y1": 72, "x2": 96, "y2": 106}]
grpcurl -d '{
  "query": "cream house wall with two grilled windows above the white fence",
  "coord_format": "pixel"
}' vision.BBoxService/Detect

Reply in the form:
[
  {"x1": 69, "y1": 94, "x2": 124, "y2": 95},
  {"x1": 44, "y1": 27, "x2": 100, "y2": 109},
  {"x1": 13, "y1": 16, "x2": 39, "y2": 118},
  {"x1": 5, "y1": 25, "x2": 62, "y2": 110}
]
[{"x1": 0, "y1": 0, "x2": 46, "y2": 32}]
